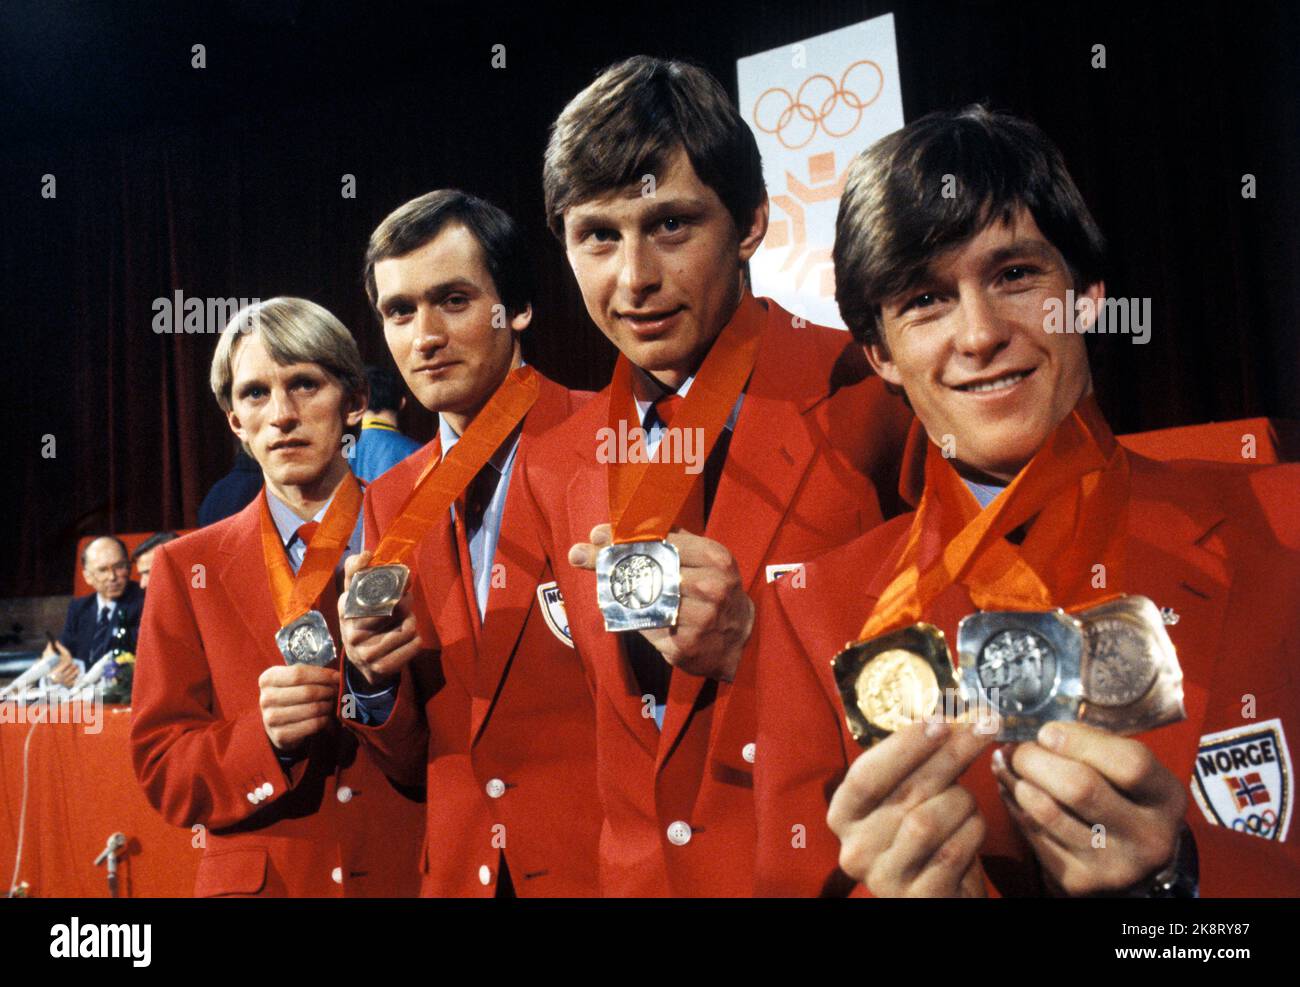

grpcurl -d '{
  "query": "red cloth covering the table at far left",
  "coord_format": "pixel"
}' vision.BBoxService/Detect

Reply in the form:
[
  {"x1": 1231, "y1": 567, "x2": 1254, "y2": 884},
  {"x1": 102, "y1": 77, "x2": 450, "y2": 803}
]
[{"x1": 0, "y1": 704, "x2": 202, "y2": 897}]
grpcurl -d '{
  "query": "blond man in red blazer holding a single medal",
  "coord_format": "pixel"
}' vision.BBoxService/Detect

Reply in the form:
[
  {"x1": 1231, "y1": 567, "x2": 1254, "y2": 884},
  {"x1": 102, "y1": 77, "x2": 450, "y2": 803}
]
[{"x1": 131, "y1": 298, "x2": 423, "y2": 897}]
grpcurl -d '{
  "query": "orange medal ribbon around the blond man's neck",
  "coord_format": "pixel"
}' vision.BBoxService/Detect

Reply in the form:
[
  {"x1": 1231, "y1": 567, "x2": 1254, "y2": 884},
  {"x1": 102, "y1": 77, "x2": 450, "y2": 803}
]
[{"x1": 261, "y1": 469, "x2": 361, "y2": 627}]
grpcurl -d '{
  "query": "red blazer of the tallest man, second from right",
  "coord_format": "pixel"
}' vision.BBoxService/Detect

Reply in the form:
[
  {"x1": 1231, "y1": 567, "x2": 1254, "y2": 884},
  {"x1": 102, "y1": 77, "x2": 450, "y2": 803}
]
[{"x1": 524, "y1": 300, "x2": 911, "y2": 896}]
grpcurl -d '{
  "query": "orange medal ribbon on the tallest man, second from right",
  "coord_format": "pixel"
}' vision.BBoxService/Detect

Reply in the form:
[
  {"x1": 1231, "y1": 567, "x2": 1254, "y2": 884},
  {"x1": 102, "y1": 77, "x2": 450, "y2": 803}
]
[{"x1": 608, "y1": 293, "x2": 767, "y2": 545}]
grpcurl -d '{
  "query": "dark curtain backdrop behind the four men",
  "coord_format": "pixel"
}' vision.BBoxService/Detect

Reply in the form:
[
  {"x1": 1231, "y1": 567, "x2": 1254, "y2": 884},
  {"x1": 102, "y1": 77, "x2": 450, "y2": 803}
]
[{"x1": 0, "y1": 0, "x2": 1300, "y2": 596}]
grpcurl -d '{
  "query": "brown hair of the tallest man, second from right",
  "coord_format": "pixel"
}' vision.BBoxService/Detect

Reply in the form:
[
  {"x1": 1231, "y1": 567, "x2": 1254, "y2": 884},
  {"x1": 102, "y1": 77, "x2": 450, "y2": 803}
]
[{"x1": 542, "y1": 55, "x2": 767, "y2": 241}]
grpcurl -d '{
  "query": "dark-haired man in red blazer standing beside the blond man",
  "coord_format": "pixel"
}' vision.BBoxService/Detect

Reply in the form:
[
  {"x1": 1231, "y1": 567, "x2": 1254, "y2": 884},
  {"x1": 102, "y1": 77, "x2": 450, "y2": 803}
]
[{"x1": 342, "y1": 190, "x2": 601, "y2": 896}]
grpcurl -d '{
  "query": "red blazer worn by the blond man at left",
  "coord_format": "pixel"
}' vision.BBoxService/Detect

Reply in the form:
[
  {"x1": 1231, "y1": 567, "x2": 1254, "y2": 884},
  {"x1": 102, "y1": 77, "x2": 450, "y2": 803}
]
[{"x1": 131, "y1": 497, "x2": 424, "y2": 897}]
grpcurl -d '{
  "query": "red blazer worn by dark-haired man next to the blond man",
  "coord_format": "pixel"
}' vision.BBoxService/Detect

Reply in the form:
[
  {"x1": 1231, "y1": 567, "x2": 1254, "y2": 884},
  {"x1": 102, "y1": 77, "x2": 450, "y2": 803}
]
[{"x1": 346, "y1": 377, "x2": 601, "y2": 896}]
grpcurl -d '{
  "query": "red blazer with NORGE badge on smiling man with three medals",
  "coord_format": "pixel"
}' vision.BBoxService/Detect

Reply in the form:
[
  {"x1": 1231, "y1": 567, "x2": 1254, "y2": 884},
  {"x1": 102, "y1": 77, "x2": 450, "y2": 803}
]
[{"x1": 751, "y1": 453, "x2": 1300, "y2": 897}]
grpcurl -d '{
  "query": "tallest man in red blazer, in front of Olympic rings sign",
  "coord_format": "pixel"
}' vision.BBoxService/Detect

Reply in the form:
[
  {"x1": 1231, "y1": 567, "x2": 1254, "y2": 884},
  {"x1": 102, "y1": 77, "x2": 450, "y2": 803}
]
[{"x1": 524, "y1": 57, "x2": 910, "y2": 896}]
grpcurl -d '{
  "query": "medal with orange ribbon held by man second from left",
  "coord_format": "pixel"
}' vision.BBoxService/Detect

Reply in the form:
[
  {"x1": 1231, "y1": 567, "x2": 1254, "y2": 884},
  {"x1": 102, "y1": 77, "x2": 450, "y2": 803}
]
[{"x1": 343, "y1": 367, "x2": 542, "y2": 619}]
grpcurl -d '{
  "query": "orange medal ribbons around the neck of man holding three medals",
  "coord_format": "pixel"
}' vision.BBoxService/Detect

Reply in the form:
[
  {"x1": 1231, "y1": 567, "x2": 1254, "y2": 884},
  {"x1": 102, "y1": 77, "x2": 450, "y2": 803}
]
[{"x1": 858, "y1": 397, "x2": 1128, "y2": 641}]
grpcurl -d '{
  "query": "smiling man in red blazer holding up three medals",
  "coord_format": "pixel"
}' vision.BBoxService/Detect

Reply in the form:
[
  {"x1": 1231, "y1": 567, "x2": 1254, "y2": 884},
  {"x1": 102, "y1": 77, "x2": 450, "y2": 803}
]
[{"x1": 748, "y1": 107, "x2": 1300, "y2": 897}]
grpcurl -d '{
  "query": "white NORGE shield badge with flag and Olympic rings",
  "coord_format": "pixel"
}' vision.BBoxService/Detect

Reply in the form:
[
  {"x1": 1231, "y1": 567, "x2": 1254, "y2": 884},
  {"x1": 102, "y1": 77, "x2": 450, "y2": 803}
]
[{"x1": 1192, "y1": 719, "x2": 1292, "y2": 843}]
